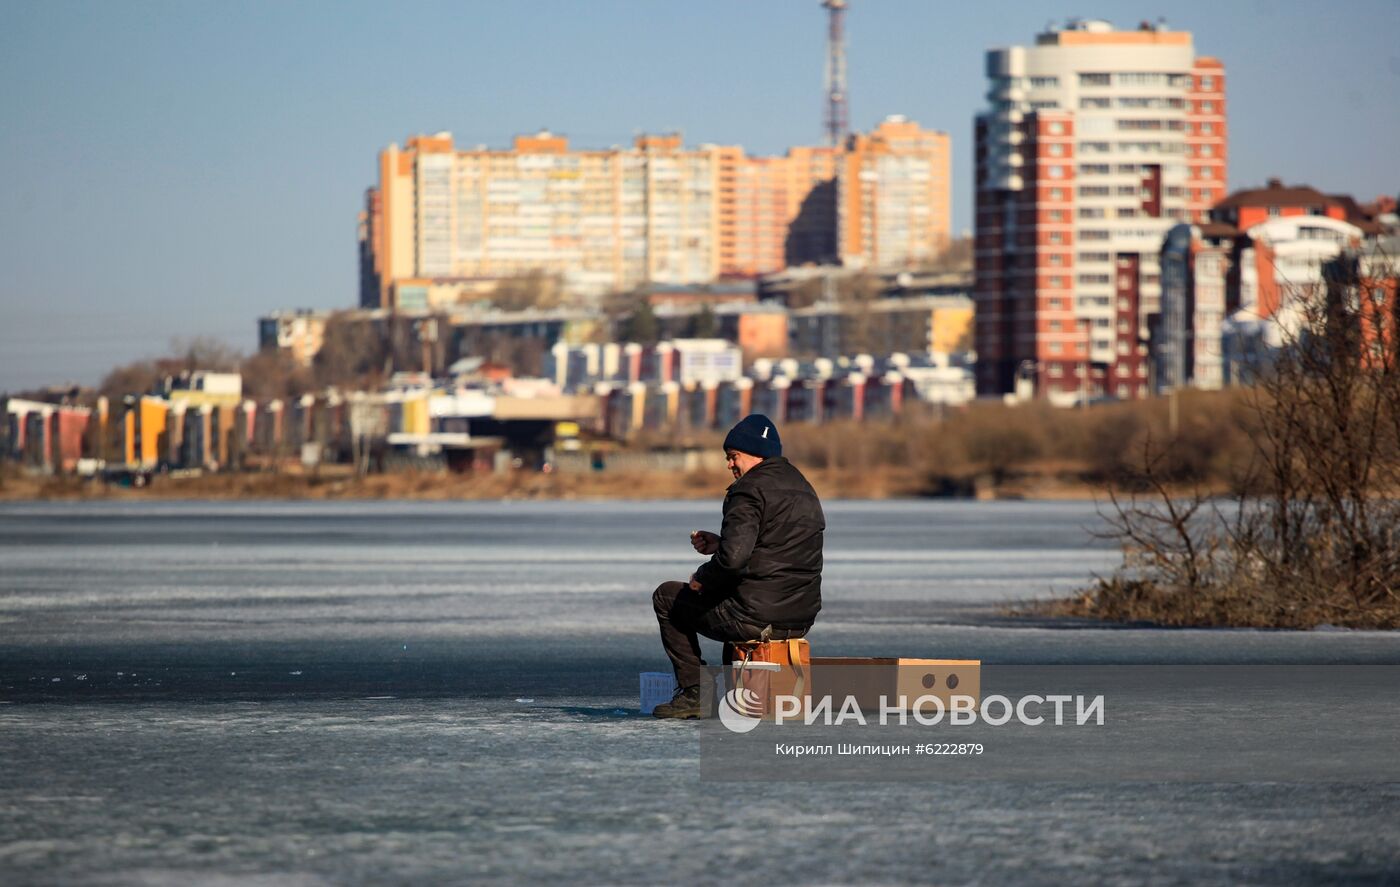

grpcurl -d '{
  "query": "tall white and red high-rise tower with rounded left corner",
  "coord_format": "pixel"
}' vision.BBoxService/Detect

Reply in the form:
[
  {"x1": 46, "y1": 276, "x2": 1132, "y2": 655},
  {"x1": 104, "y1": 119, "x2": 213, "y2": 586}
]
[{"x1": 976, "y1": 21, "x2": 1228, "y2": 403}]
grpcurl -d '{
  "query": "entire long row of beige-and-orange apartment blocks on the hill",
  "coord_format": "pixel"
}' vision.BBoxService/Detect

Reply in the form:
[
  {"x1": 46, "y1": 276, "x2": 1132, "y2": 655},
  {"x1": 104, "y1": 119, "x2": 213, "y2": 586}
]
[{"x1": 360, "y1": 118, "x2": 949, "y2": 308}]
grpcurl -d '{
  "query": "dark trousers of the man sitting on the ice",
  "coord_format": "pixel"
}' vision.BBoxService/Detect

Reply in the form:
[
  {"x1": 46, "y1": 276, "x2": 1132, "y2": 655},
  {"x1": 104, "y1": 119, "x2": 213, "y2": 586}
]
[{"x1": 651, "y1": 582, "x2": 806, "y2": 687}]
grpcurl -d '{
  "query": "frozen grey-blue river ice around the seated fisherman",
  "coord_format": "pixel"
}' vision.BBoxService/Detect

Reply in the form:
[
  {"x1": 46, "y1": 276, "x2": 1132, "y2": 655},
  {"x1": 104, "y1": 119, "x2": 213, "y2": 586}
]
[{"x1": 0, "y1": 497, "x2": 1400, "y2": 884}]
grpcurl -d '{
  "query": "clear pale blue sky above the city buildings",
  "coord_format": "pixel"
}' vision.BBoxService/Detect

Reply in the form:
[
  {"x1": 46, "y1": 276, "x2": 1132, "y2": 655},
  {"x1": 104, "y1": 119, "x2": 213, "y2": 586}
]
[{"x1": 0, "y1": 0, "x2": 1400, "y2": 392}]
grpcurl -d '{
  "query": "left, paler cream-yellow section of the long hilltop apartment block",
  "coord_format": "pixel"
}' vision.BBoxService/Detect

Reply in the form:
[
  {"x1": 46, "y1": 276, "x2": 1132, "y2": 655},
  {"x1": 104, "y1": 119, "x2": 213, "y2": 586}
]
[{"x1": 361, "y1": 132, "x2": 718, "y2": 308}]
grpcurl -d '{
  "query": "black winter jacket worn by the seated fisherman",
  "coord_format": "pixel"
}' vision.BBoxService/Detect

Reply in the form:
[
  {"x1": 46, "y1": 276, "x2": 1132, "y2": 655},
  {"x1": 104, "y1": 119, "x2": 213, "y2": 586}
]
[{"x1": 696, "y1": 456, "x2": 826, "y2": 630}]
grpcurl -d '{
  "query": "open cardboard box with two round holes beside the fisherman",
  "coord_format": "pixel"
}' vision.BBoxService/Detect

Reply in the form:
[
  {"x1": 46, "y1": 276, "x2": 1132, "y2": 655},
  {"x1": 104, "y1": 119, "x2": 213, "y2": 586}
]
[{"x1": 812, "y1": 656, "x2": 981, "y2": 711}]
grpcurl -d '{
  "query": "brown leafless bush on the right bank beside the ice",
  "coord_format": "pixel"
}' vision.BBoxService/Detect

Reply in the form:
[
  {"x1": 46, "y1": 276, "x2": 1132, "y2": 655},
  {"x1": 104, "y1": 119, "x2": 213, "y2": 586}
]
[{"x1": 1054, "y1": 247, "x2": 1400, "y2": 628}]
